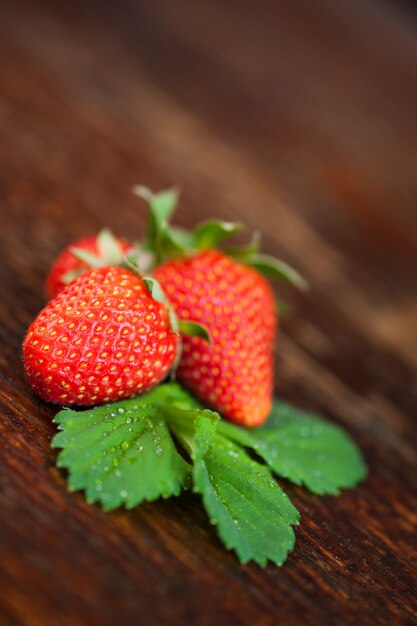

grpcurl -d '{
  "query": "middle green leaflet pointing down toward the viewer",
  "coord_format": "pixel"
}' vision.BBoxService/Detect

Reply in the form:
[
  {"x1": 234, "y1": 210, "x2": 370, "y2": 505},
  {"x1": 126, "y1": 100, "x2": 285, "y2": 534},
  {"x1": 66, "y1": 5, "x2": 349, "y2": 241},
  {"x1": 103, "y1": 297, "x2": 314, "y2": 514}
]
[{"x1": 169, "y1": 408, "x2": 299, "y2": 566}]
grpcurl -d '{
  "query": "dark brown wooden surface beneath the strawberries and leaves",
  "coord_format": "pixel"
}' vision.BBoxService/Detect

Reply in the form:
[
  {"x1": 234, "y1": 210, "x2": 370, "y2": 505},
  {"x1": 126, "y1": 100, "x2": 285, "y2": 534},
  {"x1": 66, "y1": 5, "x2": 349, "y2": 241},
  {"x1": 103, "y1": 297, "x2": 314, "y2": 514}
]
[{"x1": 0, "y1": 0, "x2": 417, "y2": 626}]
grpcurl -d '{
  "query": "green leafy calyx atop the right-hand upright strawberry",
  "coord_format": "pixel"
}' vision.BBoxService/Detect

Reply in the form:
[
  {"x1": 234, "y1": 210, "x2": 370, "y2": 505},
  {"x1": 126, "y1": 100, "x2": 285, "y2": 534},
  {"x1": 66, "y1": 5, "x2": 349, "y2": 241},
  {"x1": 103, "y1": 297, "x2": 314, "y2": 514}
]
[{"x1": 132, "y1": 180, "x2": 307, "y2": 290}]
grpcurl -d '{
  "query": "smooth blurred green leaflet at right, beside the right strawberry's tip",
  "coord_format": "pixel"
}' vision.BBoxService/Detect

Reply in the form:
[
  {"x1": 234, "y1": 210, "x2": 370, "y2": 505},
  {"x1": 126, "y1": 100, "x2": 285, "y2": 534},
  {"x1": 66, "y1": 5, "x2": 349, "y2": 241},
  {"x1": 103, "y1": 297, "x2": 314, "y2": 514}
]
[{"x1": 221, "y1": 401, "x2": 366, "y2": 494}]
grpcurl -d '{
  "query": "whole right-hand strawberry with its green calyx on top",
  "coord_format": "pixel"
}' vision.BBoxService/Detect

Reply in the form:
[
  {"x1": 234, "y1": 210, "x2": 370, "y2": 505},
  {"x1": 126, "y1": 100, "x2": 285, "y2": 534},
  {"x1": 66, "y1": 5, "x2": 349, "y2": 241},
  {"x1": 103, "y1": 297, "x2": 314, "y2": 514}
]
[{"x1": 133, "y1": 186, "x2": 306, "y2": 427}]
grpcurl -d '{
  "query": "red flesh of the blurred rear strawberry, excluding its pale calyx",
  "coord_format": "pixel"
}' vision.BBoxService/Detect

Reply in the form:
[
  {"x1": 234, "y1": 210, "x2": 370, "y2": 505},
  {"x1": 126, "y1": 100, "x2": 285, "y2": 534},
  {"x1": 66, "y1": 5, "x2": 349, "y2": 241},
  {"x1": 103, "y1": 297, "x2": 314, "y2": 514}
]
[{"x1": 45, "y1": 235, "x2": 132, "y2": 300}]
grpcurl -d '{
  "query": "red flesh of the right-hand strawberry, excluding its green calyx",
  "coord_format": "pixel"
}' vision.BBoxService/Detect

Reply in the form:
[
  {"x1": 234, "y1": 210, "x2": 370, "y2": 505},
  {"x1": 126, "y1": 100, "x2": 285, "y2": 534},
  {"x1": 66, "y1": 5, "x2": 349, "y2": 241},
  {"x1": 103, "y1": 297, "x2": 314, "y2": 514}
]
[{"x1": 154, "y1": 250, "x2": 277, "y2": 426}]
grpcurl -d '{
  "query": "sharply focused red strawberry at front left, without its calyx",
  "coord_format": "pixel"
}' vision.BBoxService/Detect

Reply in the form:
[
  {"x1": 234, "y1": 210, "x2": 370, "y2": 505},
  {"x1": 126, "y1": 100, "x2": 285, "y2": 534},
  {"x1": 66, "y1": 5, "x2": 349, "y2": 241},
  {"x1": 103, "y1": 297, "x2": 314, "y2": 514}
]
[{"x1": 23, "y1": 267, "x2": 179, "y2": 406}]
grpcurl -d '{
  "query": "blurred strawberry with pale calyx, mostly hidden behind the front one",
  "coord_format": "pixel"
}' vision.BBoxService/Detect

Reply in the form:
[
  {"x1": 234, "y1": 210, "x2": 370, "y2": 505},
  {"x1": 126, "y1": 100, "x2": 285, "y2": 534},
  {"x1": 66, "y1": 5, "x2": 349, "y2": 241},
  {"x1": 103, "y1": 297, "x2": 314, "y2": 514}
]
[{"x1": 45, "y1": 230, "x2": 133, "y2": 300}]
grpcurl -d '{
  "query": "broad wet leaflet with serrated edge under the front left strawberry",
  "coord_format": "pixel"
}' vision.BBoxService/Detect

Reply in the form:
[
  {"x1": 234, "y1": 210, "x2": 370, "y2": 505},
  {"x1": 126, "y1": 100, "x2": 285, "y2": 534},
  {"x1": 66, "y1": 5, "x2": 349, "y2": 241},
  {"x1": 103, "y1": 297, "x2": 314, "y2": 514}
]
[{"x1": 52, "y1": 386, "x2": 190, "y2": 510}]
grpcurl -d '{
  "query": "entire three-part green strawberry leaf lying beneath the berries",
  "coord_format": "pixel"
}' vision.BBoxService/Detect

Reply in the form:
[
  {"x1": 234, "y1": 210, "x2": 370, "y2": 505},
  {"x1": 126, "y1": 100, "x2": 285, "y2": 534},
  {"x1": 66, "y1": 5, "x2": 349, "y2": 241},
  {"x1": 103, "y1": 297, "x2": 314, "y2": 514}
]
[{"x1": 52, "y1": 383, "x2": 366, "y2": 566}]
